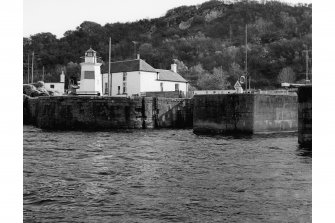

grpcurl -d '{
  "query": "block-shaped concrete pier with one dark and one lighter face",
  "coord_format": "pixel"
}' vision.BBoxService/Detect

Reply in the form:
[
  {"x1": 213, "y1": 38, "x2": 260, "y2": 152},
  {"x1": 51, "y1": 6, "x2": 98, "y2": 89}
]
[{"x1": 193, "y1": 94, "x2": 298, "y2": 134}]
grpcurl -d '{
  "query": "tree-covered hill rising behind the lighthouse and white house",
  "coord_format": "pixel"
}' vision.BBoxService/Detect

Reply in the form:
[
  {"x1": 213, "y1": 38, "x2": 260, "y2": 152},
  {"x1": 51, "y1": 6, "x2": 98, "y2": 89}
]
[{"x1": 23, "y1": 0, "x2": 312, "y2": 89}]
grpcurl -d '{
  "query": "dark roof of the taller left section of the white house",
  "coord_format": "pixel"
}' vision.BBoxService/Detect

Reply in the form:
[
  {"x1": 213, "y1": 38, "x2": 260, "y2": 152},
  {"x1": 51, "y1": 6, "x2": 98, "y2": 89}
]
[{"x1": 111, "y1": 59, "x2": 157, "y2": 73}]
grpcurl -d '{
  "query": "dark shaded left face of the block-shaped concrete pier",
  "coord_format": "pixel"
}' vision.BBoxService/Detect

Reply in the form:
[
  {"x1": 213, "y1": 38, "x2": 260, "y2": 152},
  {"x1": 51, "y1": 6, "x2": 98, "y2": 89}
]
[{"x1": 193, "y1": 94, "x2": 254, "y2": 134}]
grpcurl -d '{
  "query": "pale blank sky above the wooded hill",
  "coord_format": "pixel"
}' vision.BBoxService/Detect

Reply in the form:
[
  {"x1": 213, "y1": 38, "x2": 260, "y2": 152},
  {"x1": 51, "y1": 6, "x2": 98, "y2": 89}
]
[{"x1": 23, "y1": 0, "x2": 312, "y2": 38}]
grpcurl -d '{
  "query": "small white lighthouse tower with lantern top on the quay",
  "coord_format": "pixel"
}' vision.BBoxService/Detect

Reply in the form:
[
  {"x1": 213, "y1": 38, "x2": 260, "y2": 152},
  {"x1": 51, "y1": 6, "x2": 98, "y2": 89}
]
[{"x1": 77, "y1": 48, "x2": 102, "y2": 95}]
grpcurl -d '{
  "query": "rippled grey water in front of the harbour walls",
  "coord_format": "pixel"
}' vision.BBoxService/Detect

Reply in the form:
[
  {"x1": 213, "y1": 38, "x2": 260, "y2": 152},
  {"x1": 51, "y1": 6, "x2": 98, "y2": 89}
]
[{"x1": 23, "y1": 126, "x2": 312, "y2": 222}]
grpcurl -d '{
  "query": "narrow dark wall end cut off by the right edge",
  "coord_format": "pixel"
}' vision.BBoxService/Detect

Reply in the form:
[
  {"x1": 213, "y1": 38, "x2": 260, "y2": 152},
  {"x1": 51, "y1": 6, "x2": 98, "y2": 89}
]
[{"x1": 298, "y1": 86, "x2": 312, "y2": 147}]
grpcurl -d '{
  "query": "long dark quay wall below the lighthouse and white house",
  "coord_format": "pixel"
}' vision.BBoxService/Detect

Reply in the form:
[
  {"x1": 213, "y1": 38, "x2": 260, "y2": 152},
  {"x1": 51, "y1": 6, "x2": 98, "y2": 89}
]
[{"x1": 23, "y1": 96, "x2": 193, "y2": 130}]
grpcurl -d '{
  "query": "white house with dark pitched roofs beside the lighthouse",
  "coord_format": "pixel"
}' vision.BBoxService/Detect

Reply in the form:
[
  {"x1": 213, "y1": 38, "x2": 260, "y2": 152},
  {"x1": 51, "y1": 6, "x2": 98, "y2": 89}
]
[{"x1": 103, "y1": 59, "x2": 188, "y2": 96}]
